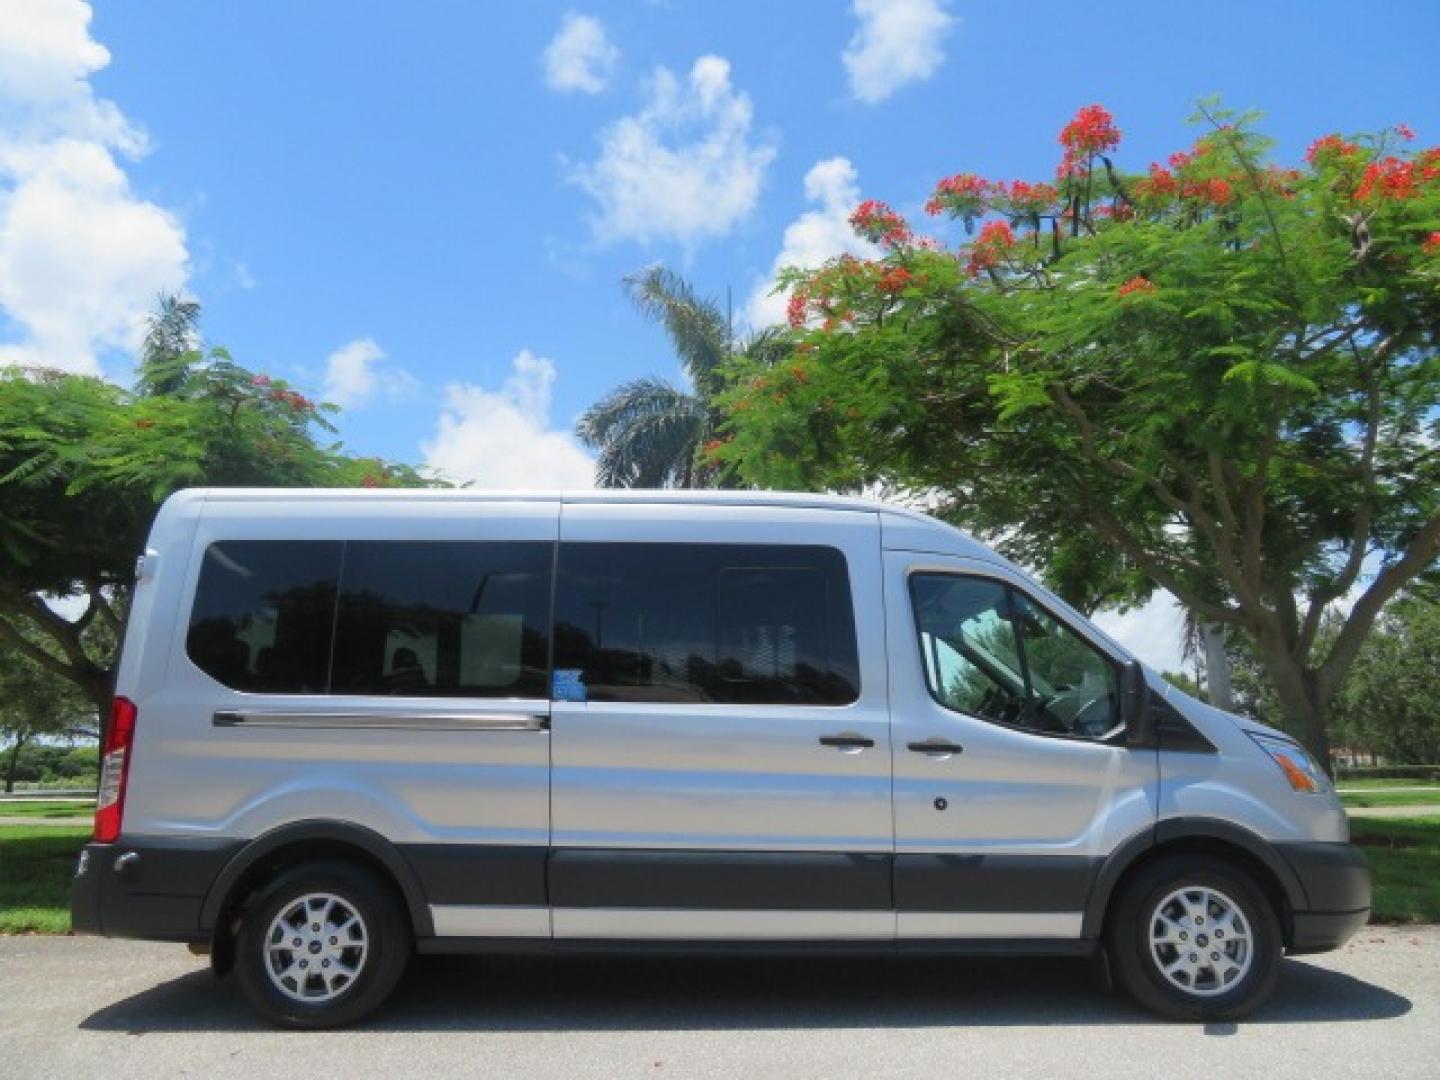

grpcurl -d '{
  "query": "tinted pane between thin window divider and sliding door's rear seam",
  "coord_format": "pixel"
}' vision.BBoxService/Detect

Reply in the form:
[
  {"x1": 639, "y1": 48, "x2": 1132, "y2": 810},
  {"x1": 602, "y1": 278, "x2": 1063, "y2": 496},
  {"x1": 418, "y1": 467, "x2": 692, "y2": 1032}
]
[{"x1": 333, "y1": 541, "x2": 553, "y2": 697}]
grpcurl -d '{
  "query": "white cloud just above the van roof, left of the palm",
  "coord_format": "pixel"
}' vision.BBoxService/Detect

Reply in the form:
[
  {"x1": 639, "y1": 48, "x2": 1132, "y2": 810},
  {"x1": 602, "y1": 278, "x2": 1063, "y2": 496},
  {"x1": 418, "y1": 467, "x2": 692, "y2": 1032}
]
[{"x1": 420, "y1": 348, "x2": 595, "y2": 490}]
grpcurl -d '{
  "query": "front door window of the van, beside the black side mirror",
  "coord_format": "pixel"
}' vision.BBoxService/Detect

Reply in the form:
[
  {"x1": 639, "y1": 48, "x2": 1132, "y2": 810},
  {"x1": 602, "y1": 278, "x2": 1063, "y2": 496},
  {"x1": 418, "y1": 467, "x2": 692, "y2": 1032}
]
[{"x1": 910, "y1": 575, "x2": 1119, "y2": 739}]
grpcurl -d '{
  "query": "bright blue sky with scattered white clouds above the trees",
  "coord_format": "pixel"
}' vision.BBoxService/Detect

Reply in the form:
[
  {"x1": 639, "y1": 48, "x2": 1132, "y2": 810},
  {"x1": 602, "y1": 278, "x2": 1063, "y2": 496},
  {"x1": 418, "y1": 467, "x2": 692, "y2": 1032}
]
[{"x1": 0, "y1": 0, "x2": 1440, "y2": 668}]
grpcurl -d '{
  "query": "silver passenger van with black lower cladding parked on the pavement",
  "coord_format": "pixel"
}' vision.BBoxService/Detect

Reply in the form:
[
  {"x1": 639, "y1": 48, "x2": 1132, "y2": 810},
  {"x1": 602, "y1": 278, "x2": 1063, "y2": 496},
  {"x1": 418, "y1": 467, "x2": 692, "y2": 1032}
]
[{"x1": 72, "y1": 490, "x2": 1369, "y2": 1027}]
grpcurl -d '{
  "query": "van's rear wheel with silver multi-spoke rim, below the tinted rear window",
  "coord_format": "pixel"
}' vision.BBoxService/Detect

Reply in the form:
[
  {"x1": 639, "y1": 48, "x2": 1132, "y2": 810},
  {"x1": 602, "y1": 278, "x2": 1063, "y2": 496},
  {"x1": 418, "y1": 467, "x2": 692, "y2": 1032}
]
[{"x1": 235, "y1": 861, "x2": 410, "y2": 1028}]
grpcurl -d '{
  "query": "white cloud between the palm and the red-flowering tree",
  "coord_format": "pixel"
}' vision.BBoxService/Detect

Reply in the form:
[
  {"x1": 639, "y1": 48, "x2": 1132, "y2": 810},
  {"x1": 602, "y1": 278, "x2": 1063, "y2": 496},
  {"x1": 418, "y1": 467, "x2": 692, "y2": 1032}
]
[{"x1": 746, "y1": 157, "x2": 880, "y2": 327}]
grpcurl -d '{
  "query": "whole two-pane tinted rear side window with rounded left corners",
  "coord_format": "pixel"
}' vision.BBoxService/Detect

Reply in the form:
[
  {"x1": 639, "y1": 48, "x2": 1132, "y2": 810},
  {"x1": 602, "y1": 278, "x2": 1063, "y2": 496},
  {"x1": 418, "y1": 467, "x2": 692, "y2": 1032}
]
[{"x1": 186, "y1": 540, "x2": 554, "y2": 697}]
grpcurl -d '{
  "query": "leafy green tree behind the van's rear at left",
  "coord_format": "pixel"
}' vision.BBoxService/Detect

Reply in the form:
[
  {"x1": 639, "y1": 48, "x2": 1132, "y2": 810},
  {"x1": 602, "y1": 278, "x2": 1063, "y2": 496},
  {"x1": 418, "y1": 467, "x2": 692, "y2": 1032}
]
[{"x1": 0, "y1": 300, "x2": 425, "y2": 710}]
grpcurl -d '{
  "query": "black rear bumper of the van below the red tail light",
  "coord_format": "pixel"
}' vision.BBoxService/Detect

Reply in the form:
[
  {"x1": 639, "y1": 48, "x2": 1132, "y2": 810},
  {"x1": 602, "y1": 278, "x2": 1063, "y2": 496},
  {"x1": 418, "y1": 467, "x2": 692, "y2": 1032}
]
[{"x1": 71, "y1": 840, "x2": 233, "y2": 942}]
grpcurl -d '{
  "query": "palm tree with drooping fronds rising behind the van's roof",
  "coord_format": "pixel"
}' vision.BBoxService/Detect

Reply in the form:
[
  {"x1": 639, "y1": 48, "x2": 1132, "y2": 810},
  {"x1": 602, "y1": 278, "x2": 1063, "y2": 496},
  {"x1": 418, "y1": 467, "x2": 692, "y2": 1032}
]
[{"x1": 575, "y1": 266, "x2": 789, "y2": 488}]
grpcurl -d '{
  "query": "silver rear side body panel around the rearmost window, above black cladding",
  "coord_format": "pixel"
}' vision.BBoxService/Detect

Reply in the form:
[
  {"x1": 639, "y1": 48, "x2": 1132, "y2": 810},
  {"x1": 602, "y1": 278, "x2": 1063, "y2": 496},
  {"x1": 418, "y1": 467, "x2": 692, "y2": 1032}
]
[{"x1": 115, "y1": 492, "x2": 560, "y2": 848}]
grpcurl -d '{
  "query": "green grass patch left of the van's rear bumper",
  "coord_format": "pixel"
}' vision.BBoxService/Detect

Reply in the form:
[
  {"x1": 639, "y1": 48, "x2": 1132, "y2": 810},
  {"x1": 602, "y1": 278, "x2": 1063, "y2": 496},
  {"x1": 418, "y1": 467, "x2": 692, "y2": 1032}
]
[{"x1": 0, "y1": 825, "x2": 91, "y2": 933}]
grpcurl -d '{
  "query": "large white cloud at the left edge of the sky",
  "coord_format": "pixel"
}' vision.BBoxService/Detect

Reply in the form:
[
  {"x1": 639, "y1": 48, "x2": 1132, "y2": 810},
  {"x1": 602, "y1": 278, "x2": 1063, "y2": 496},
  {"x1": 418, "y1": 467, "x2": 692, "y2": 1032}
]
[{"x1": 0, "y1": 0, "x2": 189, "y2": 373}]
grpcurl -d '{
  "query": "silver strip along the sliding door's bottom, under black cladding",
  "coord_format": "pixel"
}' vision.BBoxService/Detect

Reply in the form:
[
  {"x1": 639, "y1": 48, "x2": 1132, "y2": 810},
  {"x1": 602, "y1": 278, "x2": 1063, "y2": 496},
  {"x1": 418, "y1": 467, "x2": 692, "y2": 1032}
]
[{"x1": 552, "y1": 907, "x2": 896, "y2": 942}]
